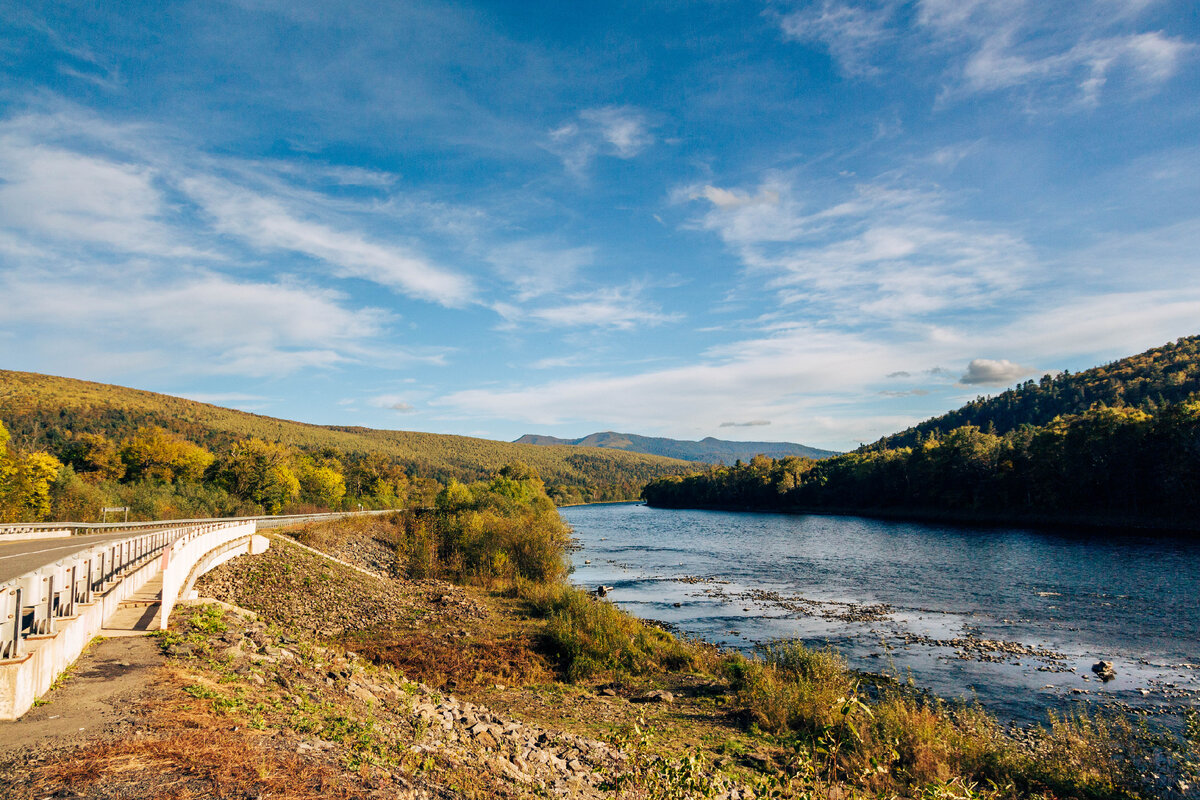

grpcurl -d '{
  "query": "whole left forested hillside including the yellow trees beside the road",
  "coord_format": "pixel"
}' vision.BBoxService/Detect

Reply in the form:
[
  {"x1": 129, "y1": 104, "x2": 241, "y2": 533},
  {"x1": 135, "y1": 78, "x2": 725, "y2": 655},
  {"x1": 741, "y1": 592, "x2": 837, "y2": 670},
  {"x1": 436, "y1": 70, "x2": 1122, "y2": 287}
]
[{"x1": 0, "y1": 371, "x2": 689, "y2": 521}]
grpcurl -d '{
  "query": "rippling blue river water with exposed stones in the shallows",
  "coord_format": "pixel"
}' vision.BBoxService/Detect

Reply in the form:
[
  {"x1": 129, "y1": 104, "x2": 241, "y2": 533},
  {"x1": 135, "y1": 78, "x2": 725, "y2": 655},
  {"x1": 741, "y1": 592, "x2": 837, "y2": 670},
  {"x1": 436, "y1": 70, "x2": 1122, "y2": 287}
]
[{"x1": 560, "y1": 504, "x2": 1200, "y2": 722}]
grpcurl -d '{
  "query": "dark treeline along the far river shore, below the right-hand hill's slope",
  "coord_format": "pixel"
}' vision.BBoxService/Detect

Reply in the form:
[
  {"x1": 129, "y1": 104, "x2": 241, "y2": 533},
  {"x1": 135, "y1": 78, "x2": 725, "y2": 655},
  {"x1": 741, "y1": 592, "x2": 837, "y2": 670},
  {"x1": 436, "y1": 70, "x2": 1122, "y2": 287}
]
[{"x1": 642, "y1": 399, "x2": 1200, "y2": 527}]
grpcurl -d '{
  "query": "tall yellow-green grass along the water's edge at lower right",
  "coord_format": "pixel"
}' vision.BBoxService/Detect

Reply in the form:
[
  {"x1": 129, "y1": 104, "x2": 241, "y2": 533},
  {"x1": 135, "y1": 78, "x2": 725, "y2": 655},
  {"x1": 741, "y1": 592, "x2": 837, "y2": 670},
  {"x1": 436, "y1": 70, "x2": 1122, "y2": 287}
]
[{"x1": 721, "y1": 642, "x2": 1140, "y2": 799}]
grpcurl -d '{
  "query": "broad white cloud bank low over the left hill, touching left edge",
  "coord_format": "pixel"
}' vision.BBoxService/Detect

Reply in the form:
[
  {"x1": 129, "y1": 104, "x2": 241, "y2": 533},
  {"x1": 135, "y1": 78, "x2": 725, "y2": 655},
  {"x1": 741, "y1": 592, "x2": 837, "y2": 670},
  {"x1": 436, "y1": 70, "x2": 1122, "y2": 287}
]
[{"x1": 0, "y1": 269, "x2": 405, "y2": 375}]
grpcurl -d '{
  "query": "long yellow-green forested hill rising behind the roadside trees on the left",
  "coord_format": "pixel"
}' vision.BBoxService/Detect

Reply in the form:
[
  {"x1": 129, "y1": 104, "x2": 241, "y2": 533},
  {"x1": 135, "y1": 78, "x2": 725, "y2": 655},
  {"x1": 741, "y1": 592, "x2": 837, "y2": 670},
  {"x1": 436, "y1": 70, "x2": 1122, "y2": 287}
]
[{"x1": 0, "y1": 371, "x2": 690, "y2": 515}]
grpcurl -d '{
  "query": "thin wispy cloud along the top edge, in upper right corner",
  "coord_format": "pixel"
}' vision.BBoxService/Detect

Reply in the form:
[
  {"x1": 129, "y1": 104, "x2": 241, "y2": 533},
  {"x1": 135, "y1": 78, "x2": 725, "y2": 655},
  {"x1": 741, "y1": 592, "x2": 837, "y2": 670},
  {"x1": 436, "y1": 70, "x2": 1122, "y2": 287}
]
[{"x1": 779, "y1": 0, "x2": 1195, "y2": 106}]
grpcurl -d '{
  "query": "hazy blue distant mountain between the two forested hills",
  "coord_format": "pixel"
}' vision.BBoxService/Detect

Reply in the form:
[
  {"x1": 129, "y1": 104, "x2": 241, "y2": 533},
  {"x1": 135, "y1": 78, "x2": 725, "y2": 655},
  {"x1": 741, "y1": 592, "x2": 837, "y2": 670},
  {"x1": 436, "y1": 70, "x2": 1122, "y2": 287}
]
[{"x1": 514, "y1": 431, "x2": 838, "y2": 464}]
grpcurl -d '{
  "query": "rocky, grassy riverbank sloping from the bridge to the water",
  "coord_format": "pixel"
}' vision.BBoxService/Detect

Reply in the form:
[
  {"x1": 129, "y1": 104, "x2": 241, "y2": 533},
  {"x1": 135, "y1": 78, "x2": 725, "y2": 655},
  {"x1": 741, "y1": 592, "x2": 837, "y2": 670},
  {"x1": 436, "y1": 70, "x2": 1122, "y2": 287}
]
[{"x1": 4, "y1": 519, "x2": 1190, "y2": 800}]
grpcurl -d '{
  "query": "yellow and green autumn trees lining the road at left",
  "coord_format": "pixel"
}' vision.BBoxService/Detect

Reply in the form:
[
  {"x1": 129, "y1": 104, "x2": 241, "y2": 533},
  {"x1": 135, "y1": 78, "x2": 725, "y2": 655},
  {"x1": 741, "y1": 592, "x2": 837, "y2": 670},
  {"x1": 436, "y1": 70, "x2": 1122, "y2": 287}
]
[{"x1": 0, "y1": 423, "x2": 432, "y2": 522}]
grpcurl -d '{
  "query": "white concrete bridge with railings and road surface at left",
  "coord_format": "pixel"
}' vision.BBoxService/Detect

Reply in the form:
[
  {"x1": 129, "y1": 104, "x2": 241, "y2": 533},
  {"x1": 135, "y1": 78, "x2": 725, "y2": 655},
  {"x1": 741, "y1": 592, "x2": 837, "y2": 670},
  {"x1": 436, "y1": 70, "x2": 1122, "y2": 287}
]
[{"x1": 0, "y1": 511, "x2": 385, "y2": 720}]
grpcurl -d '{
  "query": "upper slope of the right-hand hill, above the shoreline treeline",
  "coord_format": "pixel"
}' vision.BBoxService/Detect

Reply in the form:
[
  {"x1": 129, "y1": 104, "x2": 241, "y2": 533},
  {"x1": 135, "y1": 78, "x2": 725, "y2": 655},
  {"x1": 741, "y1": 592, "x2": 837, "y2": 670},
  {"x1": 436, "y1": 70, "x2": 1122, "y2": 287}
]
[{"x1": 870, "y1": 336, "x2": 1200, "y2": 449}]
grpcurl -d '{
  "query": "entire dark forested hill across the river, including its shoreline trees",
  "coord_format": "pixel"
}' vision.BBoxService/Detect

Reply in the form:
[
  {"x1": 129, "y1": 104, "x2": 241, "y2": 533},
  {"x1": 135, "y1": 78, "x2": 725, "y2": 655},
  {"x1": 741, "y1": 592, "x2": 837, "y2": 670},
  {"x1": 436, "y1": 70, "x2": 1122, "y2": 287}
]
[{"x1": 642, "y1": 337, "x2": 1200, "y2": 530}]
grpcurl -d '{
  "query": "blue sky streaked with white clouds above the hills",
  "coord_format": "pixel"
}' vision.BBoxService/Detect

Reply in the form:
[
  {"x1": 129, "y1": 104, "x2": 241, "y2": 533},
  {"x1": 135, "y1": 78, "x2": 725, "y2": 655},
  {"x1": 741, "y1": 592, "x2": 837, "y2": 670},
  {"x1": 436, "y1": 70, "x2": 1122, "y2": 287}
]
[{"x1": 0, "y1": 0, "x2": 1200, "y2": 450}]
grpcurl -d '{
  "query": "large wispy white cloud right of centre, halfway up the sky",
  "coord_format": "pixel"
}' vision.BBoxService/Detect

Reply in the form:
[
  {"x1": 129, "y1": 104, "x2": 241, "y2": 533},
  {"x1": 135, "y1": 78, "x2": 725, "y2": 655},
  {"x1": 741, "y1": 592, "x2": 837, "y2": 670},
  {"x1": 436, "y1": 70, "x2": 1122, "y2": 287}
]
[{"x1": 688, "y1": 175, "x2": 1031, "y2": 319}]
